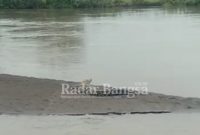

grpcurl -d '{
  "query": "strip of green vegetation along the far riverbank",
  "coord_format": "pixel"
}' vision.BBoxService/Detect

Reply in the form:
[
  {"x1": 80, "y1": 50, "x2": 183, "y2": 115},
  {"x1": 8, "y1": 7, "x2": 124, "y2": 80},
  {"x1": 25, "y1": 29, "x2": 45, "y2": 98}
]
[{"x1": 0, "y1": 0, "x2": 200, "y2": 8}]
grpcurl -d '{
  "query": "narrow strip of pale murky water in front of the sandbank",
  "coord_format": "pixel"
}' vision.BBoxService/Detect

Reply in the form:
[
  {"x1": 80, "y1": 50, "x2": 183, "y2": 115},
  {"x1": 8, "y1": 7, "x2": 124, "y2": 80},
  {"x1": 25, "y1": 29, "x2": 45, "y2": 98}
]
[{"x1": 0, "y1": 114, "x2": 200, "y2": 135}]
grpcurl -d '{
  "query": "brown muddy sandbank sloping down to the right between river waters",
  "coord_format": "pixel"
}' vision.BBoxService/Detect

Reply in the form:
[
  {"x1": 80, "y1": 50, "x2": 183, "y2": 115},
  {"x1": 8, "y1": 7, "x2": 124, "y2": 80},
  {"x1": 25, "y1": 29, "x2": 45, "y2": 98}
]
[{"x1": 0, "y1": 74, "x2": 200, "y2": 115}]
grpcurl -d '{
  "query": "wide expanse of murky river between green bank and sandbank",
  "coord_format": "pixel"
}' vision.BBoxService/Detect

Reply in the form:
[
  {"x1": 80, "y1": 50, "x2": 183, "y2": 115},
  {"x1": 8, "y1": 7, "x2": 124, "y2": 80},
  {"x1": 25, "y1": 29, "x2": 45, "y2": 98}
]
[{"x1": 0, "y1": 8, "x2": 200, "y2": 97}]
